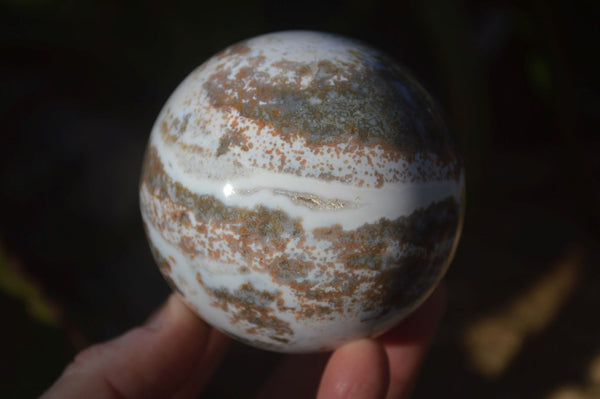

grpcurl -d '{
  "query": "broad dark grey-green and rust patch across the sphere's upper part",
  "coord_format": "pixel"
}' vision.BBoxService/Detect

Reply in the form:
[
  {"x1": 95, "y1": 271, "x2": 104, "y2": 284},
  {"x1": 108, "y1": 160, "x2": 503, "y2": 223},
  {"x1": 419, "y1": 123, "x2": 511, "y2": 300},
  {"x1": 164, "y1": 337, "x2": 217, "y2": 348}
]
[{"x1": 204, "y1": 51, "x2": 457, "y2": 162}]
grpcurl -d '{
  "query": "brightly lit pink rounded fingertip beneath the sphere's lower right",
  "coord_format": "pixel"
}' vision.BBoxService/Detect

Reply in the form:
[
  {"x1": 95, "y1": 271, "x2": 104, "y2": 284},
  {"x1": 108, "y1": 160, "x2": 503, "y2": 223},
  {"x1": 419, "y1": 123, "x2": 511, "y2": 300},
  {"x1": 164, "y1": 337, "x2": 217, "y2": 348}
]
[{"x1": 317, "y1": 339, "x2": 389, "y2": 399}]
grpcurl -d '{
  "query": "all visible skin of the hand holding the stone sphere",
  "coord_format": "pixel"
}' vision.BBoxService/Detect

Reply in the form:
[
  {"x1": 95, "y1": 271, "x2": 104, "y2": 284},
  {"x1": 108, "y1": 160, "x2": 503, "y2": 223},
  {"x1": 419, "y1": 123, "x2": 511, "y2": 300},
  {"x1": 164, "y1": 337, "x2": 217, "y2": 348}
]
[{"x1": 42, "y1": 287, "x2": 445, "y2": 399}]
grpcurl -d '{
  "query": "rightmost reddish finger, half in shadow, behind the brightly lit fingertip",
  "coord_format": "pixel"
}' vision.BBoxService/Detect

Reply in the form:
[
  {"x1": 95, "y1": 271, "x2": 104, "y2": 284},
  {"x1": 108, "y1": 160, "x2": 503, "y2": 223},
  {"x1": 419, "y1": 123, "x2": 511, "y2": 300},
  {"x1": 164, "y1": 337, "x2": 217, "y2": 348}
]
[{"x1": 379, "y1": 286, "x2": 446, "y2": 399}]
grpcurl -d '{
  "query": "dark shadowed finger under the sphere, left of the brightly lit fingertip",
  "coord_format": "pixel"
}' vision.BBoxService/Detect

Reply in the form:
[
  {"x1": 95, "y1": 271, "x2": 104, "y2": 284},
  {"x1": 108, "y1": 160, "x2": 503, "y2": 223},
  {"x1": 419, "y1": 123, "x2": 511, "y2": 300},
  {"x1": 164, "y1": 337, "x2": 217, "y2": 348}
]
[{"x1": 257, "y1": 353, "x2": 330, "y2": 399}]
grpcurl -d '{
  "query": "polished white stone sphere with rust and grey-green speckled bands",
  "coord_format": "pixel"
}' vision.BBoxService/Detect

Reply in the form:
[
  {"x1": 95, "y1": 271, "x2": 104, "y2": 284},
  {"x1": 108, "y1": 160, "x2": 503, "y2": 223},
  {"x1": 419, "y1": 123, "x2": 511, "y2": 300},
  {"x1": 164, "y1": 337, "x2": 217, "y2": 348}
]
[{"x1": 140, "y1": 32, "x2": 464, "y2": 352}]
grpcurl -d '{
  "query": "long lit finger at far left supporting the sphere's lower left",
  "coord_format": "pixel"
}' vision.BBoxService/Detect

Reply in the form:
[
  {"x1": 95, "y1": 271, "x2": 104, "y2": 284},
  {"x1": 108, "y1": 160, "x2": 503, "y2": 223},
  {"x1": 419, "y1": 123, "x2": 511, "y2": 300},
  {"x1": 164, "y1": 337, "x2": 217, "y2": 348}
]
[{"x1": 43, "y1": 295, "x2": 220, "y2": 399}]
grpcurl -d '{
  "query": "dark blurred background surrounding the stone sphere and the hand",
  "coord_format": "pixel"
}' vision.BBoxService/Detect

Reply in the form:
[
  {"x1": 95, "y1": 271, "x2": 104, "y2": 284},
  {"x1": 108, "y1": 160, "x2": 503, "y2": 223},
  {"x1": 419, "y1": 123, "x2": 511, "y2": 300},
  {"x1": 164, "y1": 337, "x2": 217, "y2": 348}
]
[{"x1": 0, "y1": 0, "x2": 600, "y2": 399}]
